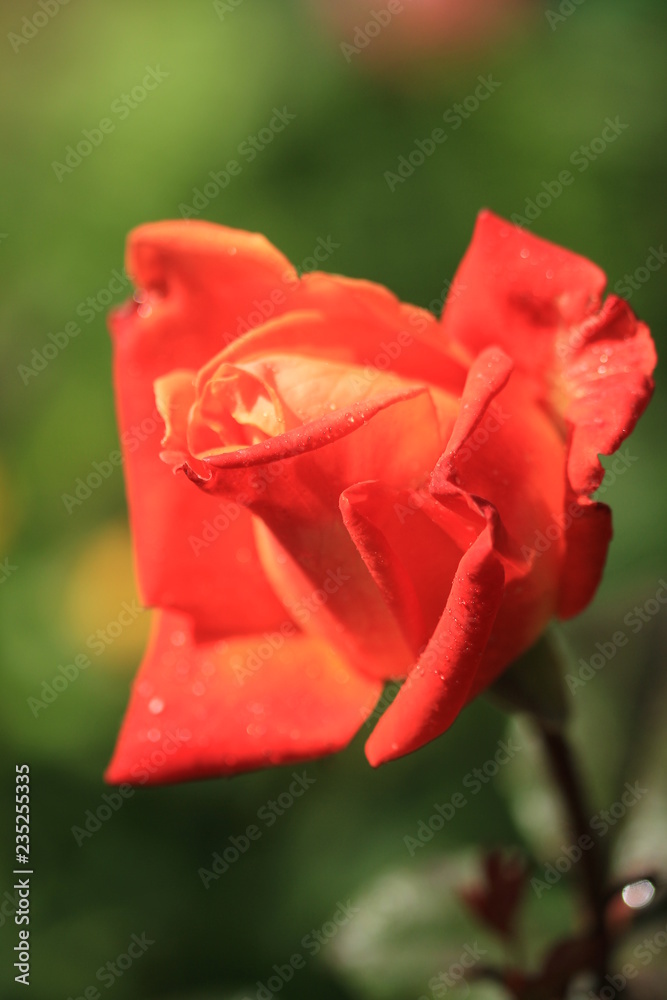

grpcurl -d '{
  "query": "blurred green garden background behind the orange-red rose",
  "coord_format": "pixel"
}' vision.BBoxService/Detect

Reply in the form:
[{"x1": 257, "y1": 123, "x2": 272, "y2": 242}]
[{"x1": 0, "y1": 0, "x2": 667, "y2": 1000}]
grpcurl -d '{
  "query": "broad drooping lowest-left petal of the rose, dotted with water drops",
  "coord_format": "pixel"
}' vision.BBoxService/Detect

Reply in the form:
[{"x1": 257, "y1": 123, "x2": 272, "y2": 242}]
[{"x1": 106, "y1": 613, "x2": 381, "y2": 785}]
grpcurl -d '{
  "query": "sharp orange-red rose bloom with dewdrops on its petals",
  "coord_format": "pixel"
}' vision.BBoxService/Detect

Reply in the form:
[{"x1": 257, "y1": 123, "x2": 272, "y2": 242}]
[{"x1": 107, "y1": 212, "x2": 655, "y2": 783}]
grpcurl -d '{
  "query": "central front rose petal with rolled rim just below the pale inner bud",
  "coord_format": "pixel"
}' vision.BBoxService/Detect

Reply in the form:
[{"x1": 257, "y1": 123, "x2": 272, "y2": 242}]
[{"x1": 183, "y1": 388, "x2": 442, "y2": 677}]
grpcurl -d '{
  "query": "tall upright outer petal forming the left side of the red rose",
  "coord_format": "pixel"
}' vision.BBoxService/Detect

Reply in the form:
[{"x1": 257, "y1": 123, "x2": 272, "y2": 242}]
[{"x1": 110, "y1": 222, "x2": 294, "y2": 635}]
